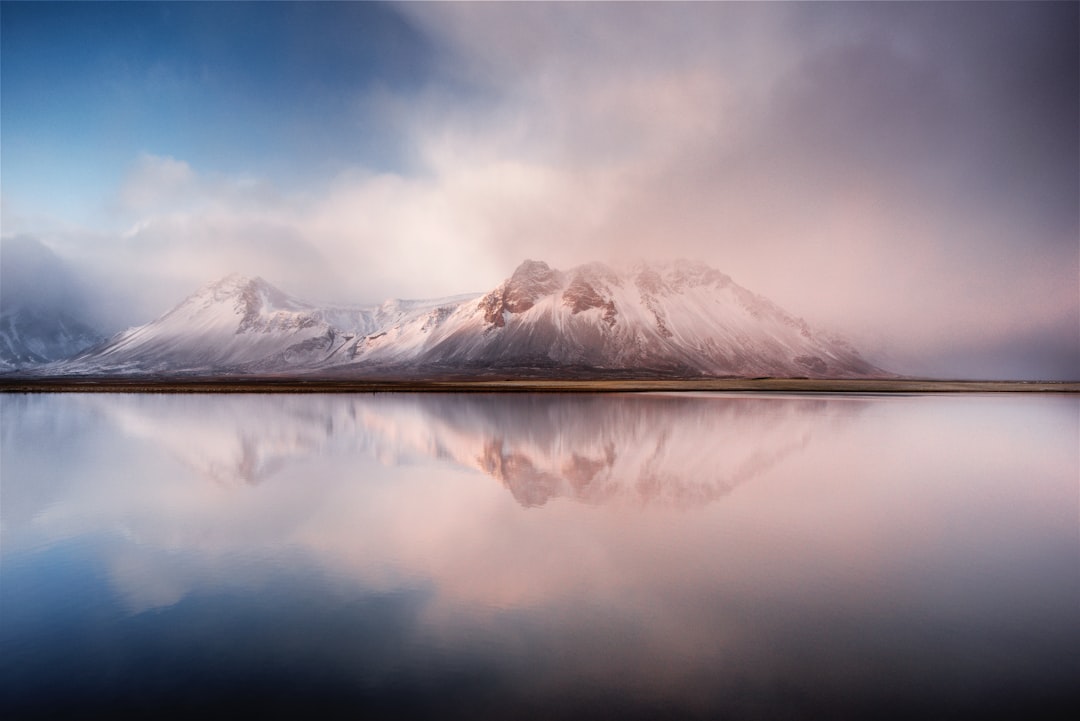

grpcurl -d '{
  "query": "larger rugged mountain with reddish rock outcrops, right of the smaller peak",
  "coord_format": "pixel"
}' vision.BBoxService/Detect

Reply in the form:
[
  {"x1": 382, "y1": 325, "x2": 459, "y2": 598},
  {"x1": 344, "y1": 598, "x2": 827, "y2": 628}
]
[{"x1": 343, "y1": 260, "x2": 882, "y2": 377}]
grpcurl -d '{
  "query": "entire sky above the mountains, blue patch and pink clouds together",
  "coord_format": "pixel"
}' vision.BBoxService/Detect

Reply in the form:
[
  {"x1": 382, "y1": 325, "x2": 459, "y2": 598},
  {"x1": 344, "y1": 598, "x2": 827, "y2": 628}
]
[{"x1": 0, "y1": 2, "x2": 1080, "y2": 380}]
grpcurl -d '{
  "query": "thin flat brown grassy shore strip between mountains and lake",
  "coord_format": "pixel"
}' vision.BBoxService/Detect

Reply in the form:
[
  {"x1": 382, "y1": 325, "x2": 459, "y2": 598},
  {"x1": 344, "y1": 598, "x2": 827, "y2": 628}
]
[{"x1": 0, "y1": 377, "x2": 1080, "y2": 393}]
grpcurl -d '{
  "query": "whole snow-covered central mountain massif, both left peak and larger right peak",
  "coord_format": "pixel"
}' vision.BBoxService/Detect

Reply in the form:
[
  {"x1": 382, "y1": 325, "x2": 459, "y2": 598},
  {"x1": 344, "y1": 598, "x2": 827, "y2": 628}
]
[{"x1": 55, "y1": 260, "x2": 883, "y2": 378}]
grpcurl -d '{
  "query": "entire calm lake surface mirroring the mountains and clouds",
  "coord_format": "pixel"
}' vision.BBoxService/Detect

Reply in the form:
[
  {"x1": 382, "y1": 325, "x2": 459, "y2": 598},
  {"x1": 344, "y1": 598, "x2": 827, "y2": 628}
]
[{"x1": 0, "y1": 394, "x2": 1080, "y2": 719}]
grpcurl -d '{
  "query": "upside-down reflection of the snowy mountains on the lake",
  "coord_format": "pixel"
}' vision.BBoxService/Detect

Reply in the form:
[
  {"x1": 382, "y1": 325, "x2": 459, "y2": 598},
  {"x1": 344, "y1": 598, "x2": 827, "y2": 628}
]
[{"x1": 78, "y1": 394, "x2": 851, "y2": 507}]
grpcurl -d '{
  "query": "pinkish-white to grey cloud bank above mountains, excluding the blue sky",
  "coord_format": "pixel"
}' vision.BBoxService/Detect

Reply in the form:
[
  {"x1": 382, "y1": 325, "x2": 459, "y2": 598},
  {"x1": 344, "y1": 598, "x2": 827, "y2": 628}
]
[{"x1": 3, "y1": 3, "x2": 1080, "y2": 378}]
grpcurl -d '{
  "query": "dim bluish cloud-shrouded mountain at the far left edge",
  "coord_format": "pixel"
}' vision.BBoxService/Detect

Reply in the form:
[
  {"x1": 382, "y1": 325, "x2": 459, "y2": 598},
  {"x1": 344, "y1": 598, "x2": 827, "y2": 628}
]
[{"x1": 0, "y1": 237, "x2": 103, "y2": 370}]
